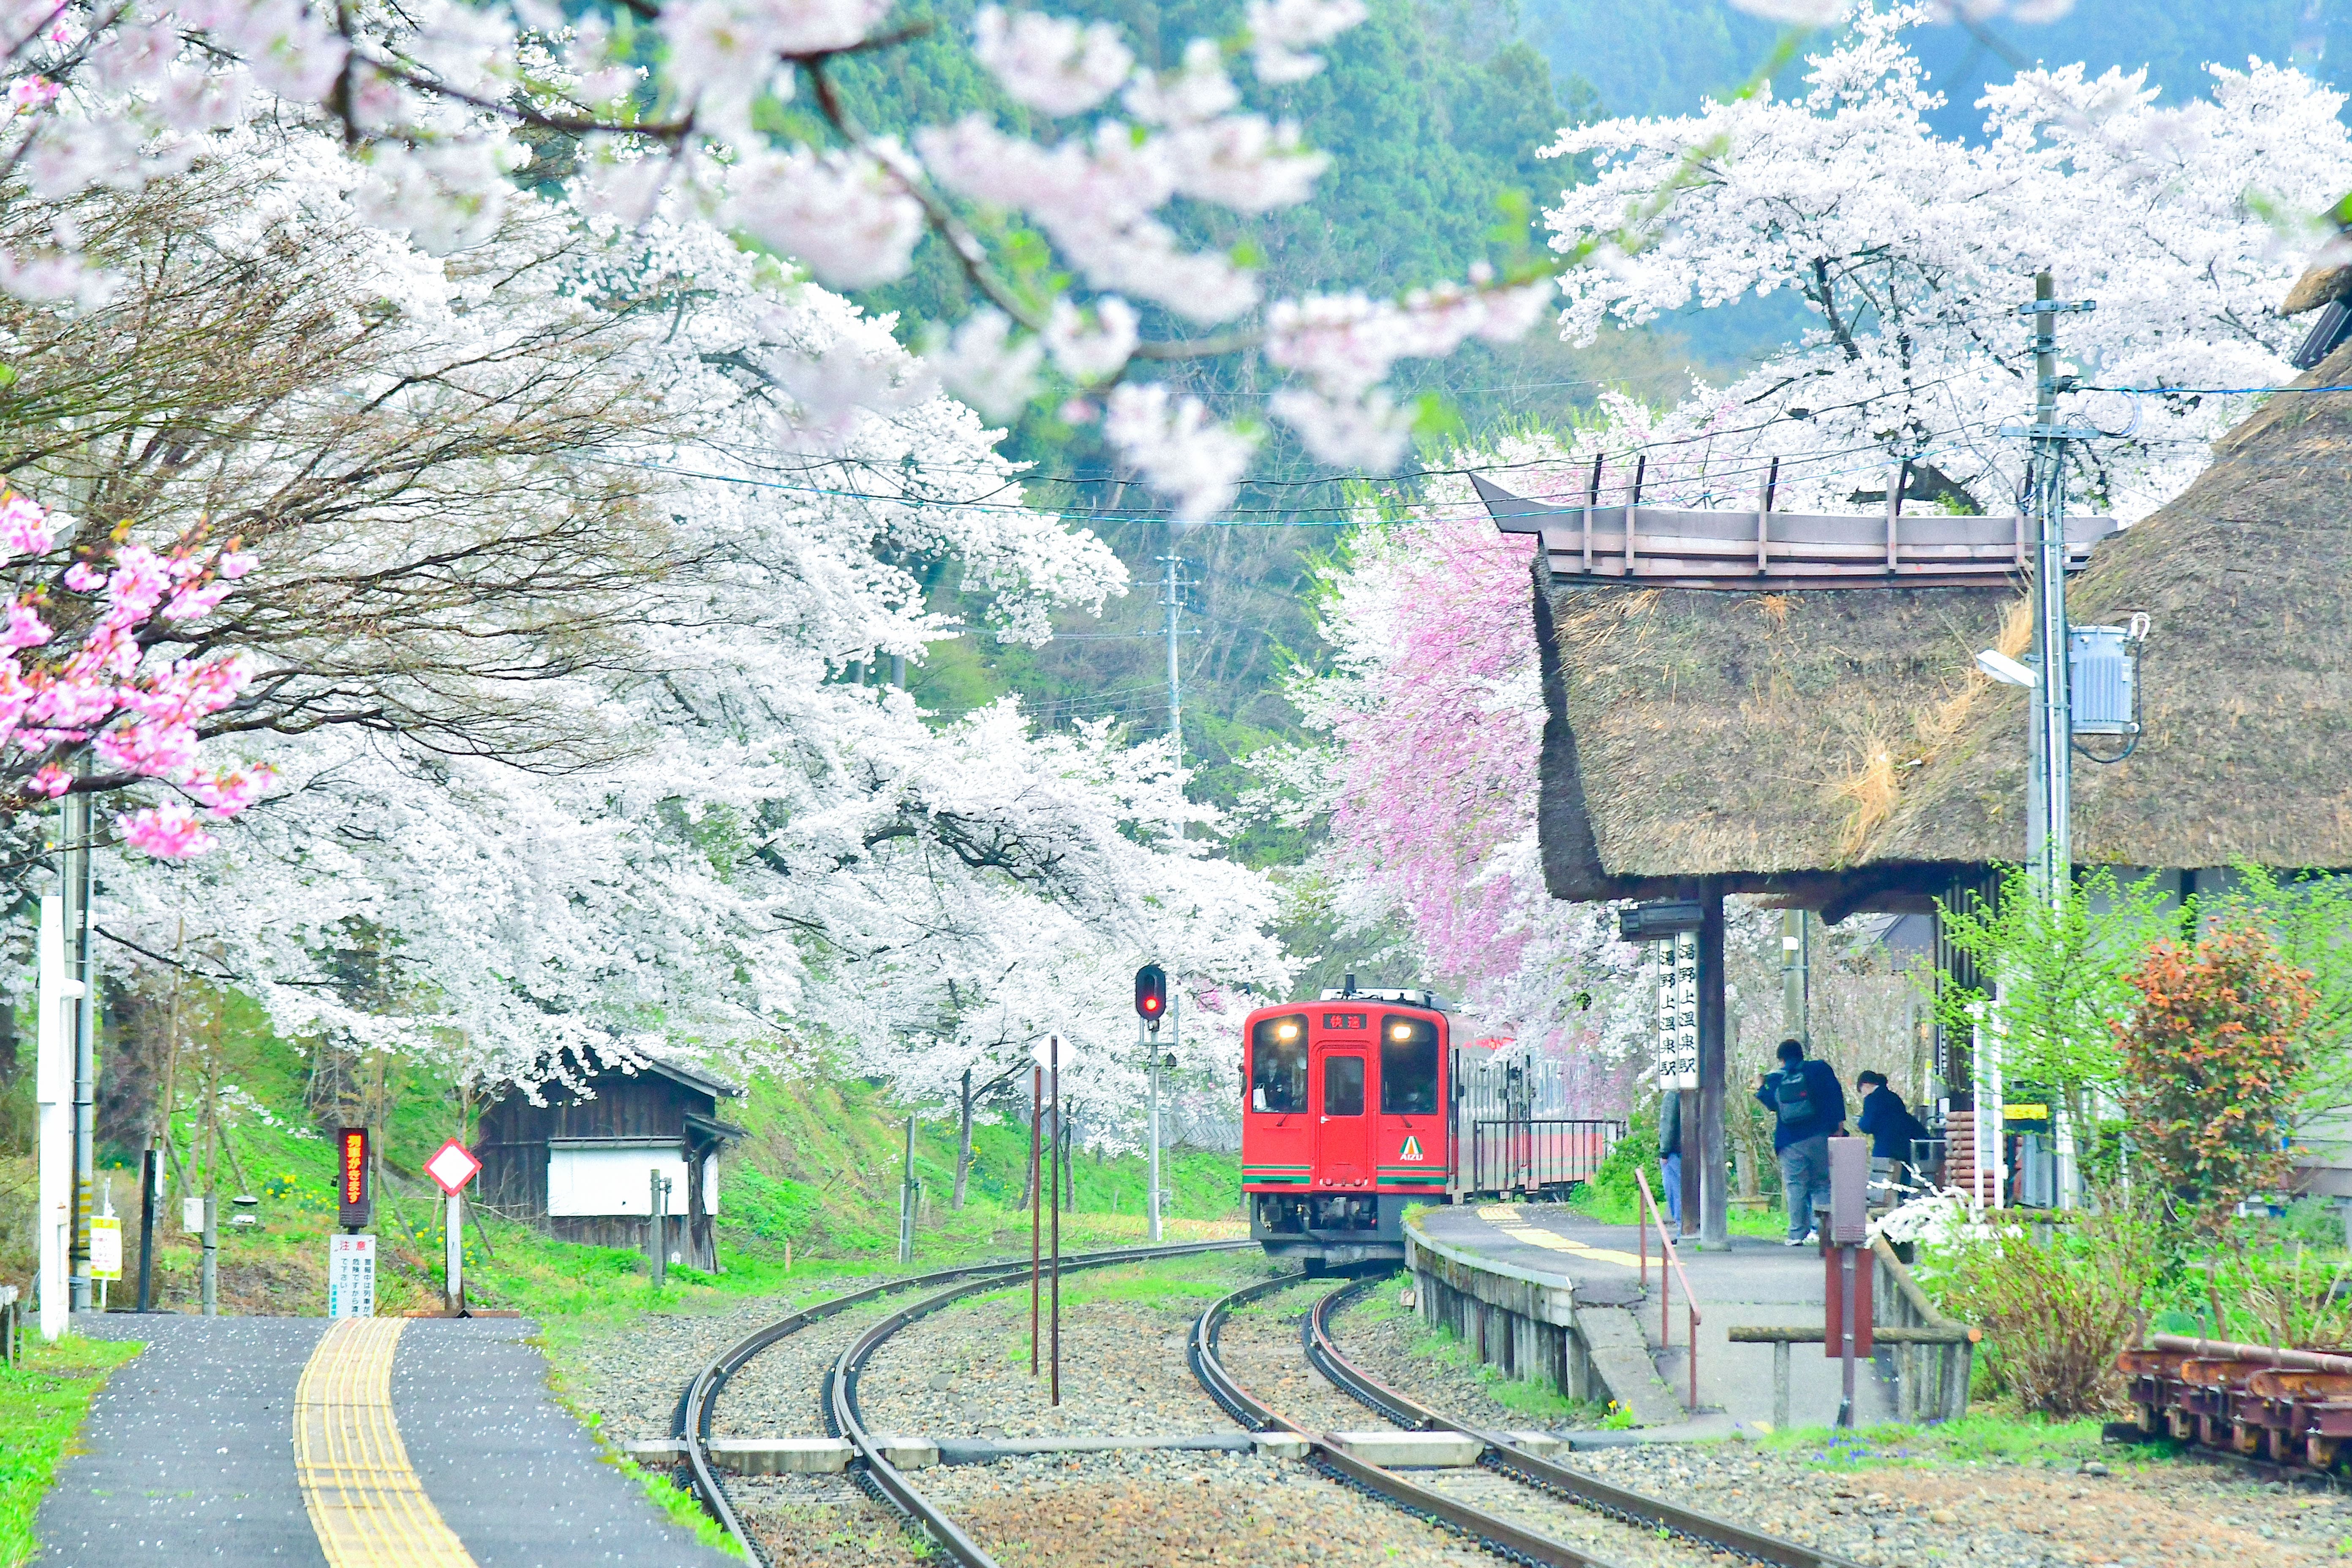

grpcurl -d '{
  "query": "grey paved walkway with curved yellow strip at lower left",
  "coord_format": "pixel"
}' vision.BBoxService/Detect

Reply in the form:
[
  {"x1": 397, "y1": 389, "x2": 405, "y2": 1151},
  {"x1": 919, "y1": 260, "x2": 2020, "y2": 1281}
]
[{"x1": 35, "y1": 1312, "x2": 741, "y2": 1568}]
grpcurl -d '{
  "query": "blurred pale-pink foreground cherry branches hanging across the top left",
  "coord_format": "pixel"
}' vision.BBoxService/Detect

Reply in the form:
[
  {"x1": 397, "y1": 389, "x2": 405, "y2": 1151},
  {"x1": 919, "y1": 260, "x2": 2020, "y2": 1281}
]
[{"x1": 0, "y1": 0, "x2": 1580, "y2": 517}]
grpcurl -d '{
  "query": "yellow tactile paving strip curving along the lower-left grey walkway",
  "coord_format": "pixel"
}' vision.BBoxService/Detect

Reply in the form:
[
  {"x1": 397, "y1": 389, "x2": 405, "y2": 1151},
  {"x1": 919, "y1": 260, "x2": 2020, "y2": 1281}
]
[{"x1": 294, "y1": 1317, "x2": 473, "y2": 1568}]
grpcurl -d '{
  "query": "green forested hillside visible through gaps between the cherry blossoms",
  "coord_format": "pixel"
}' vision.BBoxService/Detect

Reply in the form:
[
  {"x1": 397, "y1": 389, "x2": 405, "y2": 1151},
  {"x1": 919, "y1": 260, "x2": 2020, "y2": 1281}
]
[{"x1": 840, "y1": 0, "x2": 1721, "y2": 856}]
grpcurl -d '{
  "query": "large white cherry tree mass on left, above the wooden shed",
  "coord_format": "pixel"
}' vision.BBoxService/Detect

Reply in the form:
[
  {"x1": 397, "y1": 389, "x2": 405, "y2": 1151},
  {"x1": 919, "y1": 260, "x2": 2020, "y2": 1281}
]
[{"x1": 64, "y1": 135, "x2": 1289, "y2": 1114}]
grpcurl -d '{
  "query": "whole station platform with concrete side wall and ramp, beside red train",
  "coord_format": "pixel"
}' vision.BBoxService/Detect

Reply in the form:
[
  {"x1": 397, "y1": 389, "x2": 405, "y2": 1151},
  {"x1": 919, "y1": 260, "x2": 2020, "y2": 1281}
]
[{"x1": 1407, "y1": 1203, "x2": 1896, "y2": 1436}]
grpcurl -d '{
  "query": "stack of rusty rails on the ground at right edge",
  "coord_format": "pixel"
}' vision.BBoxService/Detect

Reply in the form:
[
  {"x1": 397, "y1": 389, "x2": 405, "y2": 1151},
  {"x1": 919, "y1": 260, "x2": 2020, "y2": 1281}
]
[{"x1": 2117, "y1": 1333, "x2": 2352, "y2": 1472}]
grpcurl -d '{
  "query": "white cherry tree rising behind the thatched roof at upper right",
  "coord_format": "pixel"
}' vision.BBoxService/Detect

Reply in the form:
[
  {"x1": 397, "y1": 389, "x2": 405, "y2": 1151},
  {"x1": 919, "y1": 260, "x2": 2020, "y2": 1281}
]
[{"x1": 1548, "y1": 5, "x2": 2352, "y2": 520}]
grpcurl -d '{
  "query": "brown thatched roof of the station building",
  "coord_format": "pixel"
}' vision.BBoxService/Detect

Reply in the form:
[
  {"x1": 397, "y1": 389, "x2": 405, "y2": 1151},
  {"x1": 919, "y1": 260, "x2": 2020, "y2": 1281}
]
[{"x1": 1536, "y1": 343, "x2": 2352, "y2": 915}]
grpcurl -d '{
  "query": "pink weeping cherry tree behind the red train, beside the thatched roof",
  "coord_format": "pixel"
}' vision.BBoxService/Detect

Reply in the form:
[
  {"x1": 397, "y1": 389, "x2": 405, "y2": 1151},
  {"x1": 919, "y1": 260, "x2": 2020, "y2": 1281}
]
[{"x1": 1266, "y1": 440, "x2": 1656, "y2": 1058}]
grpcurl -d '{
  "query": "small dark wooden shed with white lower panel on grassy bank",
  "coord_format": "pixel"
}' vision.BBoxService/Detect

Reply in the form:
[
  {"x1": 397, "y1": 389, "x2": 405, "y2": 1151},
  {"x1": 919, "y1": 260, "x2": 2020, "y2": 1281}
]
[{"x1": 475, "y1": 1058, "x2": 743, "y2": 1269}]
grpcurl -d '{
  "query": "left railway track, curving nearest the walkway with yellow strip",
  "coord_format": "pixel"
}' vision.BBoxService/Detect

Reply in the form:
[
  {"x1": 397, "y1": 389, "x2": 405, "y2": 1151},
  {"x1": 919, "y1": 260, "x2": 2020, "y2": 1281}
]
[{"x1": 670, "y1": 1241, "x2": 1256, "y2": 1568}]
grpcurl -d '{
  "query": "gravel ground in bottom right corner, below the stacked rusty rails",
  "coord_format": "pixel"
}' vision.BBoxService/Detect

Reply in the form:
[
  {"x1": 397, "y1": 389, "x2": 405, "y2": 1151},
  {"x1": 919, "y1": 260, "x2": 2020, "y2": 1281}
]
[{"x1": 1576, "y1": 1443, "x2": 2352, "y2": 1568}]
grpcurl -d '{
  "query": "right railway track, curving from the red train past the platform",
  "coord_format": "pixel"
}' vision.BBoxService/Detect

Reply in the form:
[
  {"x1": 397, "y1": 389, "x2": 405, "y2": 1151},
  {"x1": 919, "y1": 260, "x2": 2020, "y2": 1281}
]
[{"x1": 1188, "y1": 1274, "x2": 1856, "y2": 1568}]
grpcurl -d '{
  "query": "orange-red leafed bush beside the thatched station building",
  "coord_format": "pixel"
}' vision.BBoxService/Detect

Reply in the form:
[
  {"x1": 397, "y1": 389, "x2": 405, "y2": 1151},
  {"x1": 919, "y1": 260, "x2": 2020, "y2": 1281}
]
[{"x1": 2112, "y1": 926, "x2": 2314, "y2": 1232}]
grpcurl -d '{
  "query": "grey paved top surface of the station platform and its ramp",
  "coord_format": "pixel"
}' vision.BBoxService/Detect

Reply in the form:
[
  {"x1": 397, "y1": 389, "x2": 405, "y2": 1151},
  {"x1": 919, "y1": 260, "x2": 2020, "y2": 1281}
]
[{"x1": 1418, "y1": 1203, "x2": 1896, "y2": 1427}]
